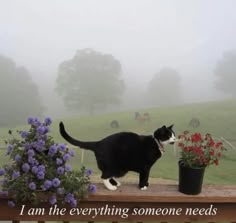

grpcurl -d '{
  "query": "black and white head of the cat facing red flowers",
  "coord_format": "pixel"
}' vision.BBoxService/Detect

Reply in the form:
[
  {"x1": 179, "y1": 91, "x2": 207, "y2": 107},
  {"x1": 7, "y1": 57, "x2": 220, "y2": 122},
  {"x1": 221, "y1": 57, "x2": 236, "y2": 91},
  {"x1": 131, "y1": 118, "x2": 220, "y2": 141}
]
[{"x1": 154, "y1": 125, "x2": 176, "y2": 145}]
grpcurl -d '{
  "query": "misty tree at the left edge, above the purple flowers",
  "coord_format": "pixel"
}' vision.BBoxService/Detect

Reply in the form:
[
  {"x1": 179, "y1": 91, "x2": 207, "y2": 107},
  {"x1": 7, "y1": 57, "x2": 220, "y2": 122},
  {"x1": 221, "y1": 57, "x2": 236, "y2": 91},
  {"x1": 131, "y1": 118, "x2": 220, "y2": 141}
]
[{"x1": 0, "y1": 56, "x2": 43, "y2": 127}]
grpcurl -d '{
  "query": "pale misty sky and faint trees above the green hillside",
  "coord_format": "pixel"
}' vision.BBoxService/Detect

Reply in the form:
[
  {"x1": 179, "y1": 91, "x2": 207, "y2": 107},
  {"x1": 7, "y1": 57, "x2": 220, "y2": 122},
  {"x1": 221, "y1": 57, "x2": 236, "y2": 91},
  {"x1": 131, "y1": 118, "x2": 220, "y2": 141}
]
[{"x1": 0, "y1": 0, "x2": 236, "y2": 122}]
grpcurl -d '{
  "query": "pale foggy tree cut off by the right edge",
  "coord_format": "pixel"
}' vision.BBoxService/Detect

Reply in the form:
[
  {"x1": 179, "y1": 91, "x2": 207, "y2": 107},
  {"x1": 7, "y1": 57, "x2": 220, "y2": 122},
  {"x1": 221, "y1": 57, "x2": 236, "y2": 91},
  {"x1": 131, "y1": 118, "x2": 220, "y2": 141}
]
[{"x1": 215, "y1": 51, "x2": 236, "y2": 96}]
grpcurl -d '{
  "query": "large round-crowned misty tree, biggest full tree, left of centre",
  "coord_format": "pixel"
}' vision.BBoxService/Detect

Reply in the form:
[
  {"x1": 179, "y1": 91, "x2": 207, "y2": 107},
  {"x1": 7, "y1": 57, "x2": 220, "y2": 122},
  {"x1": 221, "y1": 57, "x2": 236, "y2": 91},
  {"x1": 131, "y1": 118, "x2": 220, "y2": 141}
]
[{"x1": 57, "y1": 49, "x2": 124, "y2": 113}]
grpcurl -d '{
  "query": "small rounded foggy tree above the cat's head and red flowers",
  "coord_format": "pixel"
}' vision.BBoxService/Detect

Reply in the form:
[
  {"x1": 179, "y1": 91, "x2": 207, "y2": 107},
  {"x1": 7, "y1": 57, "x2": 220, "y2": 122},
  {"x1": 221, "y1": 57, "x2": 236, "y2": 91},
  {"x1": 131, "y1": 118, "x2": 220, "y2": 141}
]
[{"x1": 148, "y1": 67, "x2": 181, "y2": 106}]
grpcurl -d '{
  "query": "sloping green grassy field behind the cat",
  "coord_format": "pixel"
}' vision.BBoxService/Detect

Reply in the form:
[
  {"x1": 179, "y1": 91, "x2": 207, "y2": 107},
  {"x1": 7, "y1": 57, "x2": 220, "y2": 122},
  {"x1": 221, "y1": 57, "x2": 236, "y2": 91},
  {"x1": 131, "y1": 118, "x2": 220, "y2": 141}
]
[{"x1": 0, "y1": 100, "x2": 236, "y2": 184}]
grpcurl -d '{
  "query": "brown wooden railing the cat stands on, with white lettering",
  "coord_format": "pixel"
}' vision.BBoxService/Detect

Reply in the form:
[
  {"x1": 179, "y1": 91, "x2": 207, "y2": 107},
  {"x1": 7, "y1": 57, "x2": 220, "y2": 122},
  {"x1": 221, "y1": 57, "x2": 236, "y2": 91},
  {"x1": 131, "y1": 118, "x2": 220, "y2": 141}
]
[{"x1": 0, "y1": 184, "x2": 236, "y2": 222}]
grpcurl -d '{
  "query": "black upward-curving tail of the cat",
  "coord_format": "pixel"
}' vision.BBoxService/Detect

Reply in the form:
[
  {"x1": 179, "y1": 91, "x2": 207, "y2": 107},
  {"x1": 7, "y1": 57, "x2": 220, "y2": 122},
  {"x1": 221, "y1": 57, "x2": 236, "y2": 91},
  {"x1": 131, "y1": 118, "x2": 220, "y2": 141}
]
[{"x1": 59, "y1": 122, "x2": 97, "y2": 151}]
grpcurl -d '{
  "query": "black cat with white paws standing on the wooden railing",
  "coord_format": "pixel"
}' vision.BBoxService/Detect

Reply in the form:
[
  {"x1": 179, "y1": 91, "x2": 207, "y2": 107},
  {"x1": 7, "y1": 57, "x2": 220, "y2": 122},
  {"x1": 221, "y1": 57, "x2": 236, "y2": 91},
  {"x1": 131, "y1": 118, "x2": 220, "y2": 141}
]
[{"x1": 59, "y1": 122, "x2": 176, "y2": 190}]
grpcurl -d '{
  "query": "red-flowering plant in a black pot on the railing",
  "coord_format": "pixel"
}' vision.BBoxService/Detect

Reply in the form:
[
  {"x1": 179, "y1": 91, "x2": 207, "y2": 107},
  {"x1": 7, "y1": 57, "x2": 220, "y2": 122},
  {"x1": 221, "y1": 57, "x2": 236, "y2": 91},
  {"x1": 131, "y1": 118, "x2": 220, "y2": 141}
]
[{"x1": 178, "y1": 131, "x2": 226, "y2": 195}]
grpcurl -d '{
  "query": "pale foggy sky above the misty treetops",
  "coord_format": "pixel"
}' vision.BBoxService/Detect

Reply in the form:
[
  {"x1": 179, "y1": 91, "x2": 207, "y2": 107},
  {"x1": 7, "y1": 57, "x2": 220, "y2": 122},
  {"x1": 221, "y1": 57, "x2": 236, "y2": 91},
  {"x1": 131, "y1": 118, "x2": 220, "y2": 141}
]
[{"x1": 0, "y1": 0, "x2": 236, "y2": 111}]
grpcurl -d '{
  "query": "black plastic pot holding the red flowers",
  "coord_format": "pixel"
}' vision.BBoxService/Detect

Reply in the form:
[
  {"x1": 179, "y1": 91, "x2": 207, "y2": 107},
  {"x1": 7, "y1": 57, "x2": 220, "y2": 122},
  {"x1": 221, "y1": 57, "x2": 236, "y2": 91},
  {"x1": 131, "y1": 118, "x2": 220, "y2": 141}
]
[{"x1": 179, "y1": 161, "x2": 205, "y2": 195}]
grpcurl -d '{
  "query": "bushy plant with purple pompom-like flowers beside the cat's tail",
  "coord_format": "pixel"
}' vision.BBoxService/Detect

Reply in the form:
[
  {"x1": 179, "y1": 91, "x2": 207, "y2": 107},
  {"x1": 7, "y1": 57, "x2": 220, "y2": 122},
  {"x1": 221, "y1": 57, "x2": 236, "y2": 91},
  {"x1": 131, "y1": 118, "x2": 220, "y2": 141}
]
[{"x1": 0, "y1": 118, "x2": 96, "y2": 207}]
